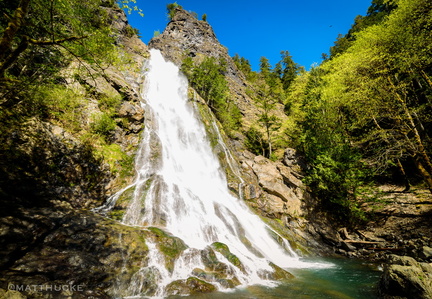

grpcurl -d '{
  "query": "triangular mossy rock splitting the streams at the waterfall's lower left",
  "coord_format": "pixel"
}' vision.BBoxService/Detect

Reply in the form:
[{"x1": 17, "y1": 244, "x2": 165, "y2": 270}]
[{"x1": 147, "y1": 227, "x2": 188, "y2": 273}]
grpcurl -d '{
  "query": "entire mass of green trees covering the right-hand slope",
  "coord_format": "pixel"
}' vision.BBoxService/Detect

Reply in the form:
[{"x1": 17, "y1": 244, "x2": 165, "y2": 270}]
[{"x1": 284, "y1": 0, "x2": 432, "y2": 222}]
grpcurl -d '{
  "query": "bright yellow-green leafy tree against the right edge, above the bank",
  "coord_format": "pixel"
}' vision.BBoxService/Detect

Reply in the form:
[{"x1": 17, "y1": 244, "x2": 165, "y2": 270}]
[{"x1": 323, "y1": 0, "x2": 432, "y2": 190}]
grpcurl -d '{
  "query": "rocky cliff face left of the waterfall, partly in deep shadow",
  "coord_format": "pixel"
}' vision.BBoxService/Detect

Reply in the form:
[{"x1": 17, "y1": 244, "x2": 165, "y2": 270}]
[{"x1": 0, "y1": 7, "x2": 154, "y2": 298}]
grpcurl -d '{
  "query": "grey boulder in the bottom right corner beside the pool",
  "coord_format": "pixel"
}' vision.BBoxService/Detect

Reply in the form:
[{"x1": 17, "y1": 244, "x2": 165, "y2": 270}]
[{"x1": 380, "y1": 255, "x2": 432, "y2": 299}]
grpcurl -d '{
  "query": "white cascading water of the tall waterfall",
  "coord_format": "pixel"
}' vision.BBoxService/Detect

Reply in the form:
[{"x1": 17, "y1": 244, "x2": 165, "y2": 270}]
[{"x1": 105, "y1": 50, "x2": 330, "y2": 296}]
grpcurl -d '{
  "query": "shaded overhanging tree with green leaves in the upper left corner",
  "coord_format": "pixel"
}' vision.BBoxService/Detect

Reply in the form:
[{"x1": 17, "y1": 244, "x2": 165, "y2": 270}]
[{"x1": 0, "y1": 0, "x2": 115, "y2": 106}]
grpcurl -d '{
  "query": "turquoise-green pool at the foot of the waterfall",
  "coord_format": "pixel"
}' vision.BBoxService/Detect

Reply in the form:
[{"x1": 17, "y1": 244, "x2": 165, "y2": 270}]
[{"x1": 170, "y1": 259, "x2": 381, "y2": 299}]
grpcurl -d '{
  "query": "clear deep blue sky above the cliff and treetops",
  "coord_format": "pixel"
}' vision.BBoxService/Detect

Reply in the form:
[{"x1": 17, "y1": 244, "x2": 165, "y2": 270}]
[{"x1": 128, "y1": 0, "x2": 371, "y2": 70}]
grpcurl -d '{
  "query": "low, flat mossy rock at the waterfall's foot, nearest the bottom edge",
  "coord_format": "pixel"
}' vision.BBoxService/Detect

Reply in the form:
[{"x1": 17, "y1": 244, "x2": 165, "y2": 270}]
[{"x1": 165, "y1": 277, "x2": 217, "y2": 296}]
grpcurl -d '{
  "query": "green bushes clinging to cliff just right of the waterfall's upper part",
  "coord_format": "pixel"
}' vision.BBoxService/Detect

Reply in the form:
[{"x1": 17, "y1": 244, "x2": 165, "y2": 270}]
[{"x1": 181, "y1": 57, "x2": 241, "y2": 134}]
